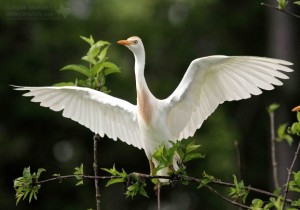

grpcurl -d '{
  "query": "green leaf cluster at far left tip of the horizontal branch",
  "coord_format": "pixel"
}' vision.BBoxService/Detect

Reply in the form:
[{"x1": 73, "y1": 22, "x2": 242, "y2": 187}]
[{"x1": 14, "y1": 167, "x2": 46, "y2": 204}]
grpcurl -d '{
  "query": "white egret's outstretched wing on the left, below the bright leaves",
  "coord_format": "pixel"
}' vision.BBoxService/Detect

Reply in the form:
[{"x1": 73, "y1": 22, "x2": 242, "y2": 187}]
[{"x1": 15, "y1": 86, "x2": 142, "y2": 148}]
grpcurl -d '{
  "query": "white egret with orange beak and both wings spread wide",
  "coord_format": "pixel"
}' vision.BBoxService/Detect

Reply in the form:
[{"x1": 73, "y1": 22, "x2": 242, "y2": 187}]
[{"x1": 16, "y1": 36, "x2": 293, "y2": 175}]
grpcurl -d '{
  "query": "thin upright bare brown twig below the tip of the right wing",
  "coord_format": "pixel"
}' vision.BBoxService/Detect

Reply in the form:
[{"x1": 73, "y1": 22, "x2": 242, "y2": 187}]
[{"x1": 269, "y1": 112, "x2": 279, "y2": 188}]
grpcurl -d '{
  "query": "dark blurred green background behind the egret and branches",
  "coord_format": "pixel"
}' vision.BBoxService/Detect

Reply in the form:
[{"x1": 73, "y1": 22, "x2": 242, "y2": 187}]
[{"x1": 0, "y1": 0, "x2": 300, "y2": 210}]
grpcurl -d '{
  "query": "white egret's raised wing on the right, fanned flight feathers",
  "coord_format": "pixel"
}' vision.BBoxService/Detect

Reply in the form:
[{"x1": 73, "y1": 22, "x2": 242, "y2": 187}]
[{"x1": 165, "y1": 56, "x2": 293, "y2": 140}]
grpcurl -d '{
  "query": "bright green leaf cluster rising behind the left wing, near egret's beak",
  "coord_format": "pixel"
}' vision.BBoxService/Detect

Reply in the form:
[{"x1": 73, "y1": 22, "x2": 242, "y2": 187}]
[{"x1": 55, "y1": 36, "x2": 120, "y2": 93}]
